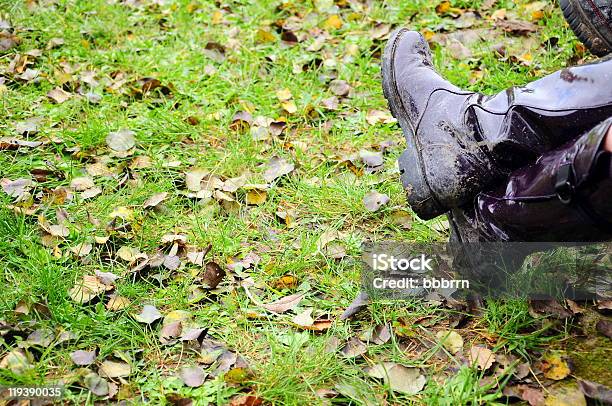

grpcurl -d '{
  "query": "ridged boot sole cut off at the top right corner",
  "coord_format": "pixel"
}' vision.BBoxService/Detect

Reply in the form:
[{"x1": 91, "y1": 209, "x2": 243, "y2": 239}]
[{"x1": 559, "y1": 0, "x2": 612, "y2": 56}]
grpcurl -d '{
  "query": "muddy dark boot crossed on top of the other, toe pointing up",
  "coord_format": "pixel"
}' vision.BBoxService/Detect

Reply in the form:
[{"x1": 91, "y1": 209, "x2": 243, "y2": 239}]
[{"x1": 382, "y1": 29, "x2": 612, "y2": 219}]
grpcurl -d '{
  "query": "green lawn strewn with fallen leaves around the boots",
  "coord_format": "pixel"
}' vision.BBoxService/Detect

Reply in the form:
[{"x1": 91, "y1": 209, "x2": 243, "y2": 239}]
[{"x1": 0, "y1": 0, "x2": 612, "y2": 405}]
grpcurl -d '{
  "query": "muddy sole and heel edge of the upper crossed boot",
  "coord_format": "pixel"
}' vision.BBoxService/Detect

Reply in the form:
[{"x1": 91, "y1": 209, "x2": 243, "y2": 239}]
[{"x1": 382, "y1": 28, "x2": 447, "y2": 220}]
